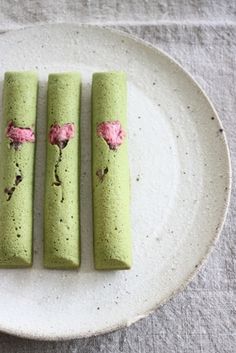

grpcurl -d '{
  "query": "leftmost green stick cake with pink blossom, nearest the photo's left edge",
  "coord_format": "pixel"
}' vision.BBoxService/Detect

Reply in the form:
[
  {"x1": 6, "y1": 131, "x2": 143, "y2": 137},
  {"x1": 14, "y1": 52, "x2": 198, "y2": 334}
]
[{"x1": 0, "y1": 72, "x2": 38, "y2": 267}]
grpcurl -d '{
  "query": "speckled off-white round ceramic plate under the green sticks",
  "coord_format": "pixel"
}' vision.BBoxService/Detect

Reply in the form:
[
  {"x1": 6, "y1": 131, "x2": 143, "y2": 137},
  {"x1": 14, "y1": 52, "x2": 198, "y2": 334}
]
[{"x1": 0, "y1": 25, "x2": 231, "y2": 339}]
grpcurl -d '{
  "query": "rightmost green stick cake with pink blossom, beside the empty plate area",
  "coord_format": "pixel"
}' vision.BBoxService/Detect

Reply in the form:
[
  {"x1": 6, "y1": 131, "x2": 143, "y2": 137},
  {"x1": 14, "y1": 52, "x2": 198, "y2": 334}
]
[{"x1": 92, "y1": 72, "x2": 132, "y2": 270}]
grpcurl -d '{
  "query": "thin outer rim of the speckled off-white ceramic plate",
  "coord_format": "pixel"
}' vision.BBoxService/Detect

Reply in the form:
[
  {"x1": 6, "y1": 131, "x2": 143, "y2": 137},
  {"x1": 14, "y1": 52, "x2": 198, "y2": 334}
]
[{"x1": 0, "y1": 22, "x2": 232, "y2": 341}]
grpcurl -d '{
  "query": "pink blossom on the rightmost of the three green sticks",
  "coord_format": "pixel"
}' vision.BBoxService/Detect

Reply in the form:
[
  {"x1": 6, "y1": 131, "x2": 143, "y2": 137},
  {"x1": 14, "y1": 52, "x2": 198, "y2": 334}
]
[{"x1": 97, "y1": 120, "x2": 126, "y2": 150}]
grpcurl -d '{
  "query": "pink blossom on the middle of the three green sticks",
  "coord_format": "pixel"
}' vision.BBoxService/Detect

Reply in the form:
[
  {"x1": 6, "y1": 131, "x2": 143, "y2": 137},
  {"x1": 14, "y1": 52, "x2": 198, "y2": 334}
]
[{"x1": 49, "y1": 123, "x2": 75, "y2": 148}]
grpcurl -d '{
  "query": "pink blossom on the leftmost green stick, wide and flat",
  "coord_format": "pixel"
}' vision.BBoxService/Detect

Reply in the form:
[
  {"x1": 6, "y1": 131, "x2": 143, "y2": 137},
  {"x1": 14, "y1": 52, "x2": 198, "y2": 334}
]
[{"x1": 6, "y1": 121, "x2": 35, "y2": 144}]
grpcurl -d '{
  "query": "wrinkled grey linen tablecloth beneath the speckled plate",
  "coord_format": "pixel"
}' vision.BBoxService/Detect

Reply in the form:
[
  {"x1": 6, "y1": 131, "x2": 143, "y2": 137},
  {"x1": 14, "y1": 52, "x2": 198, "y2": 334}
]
[{"x1": 0, "y1": 0, "x2": 236, "y2": 353}]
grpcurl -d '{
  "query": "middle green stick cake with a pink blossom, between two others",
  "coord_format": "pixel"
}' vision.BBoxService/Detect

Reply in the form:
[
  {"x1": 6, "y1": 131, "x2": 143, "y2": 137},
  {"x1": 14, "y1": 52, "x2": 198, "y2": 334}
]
[{"x1": 44, "y1": 72, "x2": 80, "y2": 269}]
